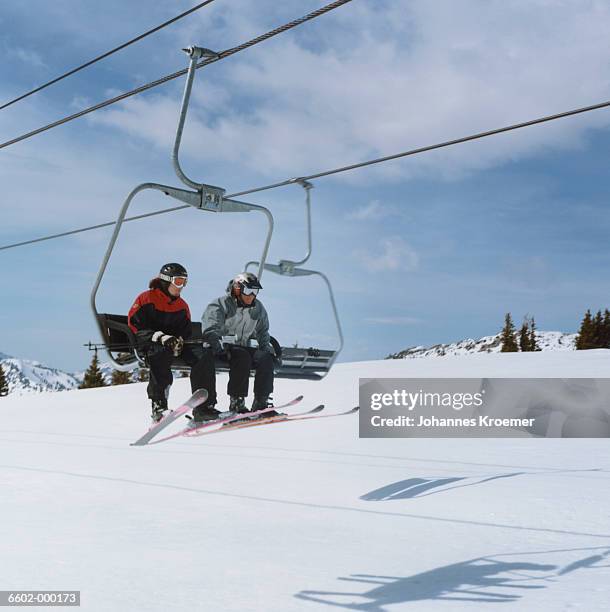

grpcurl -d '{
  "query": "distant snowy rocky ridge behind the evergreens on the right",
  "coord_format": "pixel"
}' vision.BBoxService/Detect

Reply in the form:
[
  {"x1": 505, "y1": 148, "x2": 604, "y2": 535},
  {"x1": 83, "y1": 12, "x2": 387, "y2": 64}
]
[{"x1": 386, "y1": 331, "x2": 578, "y2": 359}]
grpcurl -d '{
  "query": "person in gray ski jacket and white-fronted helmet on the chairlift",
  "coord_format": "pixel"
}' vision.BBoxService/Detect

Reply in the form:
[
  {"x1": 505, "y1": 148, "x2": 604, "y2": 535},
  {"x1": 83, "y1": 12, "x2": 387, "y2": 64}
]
[{"x1": 202, "y1": 272, "x2": 274, "y2": 416}]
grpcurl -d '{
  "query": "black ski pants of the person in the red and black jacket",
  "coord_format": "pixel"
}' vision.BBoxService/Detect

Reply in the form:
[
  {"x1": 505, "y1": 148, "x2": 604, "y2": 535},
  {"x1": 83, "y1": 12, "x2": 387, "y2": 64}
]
[{"x1": 146, "y1": 344, "x2": 215, "y2": 401}]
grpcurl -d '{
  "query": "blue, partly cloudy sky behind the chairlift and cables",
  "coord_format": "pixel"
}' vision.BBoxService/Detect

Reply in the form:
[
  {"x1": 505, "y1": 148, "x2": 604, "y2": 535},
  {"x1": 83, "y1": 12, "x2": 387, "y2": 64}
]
[{"x1": 0, "y1": 0, "x2": 610, "y2": 370}]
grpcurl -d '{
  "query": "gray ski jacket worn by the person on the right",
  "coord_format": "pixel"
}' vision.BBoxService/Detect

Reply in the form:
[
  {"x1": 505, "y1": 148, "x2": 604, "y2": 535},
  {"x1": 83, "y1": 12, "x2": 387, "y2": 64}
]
[{"x1": 202, "y1": 293, "x2": 273, "y2": 353}]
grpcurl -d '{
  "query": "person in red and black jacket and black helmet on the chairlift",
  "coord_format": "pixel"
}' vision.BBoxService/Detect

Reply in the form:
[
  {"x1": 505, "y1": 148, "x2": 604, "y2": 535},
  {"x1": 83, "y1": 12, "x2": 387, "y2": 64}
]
[{"x1": 128, "y1": 263, "x2": 219, "y2": 422}]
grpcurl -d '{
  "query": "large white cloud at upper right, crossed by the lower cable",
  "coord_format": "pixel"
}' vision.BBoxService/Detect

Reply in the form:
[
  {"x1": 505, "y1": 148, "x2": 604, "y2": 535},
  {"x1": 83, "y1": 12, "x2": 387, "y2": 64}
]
[{"x1": 85, "y1": 0, "x2": 610, "y2": 185}]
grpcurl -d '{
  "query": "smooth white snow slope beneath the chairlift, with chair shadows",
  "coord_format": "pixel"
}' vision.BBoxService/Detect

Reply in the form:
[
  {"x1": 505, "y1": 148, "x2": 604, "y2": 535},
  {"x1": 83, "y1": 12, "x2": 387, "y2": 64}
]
[{"x1": 0, "y1": 350, "x2": 610, "y2": 612}]
